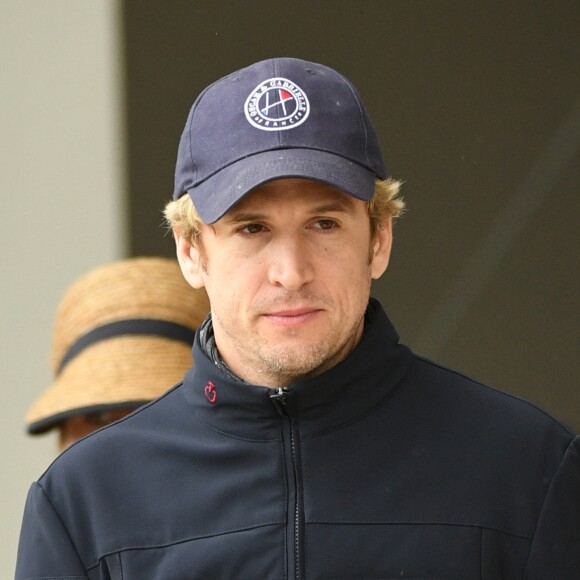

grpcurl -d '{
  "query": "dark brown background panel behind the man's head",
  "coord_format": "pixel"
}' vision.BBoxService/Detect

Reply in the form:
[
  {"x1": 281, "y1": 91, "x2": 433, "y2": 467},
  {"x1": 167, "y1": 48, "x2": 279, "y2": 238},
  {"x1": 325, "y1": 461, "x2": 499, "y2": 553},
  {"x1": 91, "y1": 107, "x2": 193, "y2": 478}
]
[{"x1": 122, "y1": 0, "x2": 580, "y2": 426}]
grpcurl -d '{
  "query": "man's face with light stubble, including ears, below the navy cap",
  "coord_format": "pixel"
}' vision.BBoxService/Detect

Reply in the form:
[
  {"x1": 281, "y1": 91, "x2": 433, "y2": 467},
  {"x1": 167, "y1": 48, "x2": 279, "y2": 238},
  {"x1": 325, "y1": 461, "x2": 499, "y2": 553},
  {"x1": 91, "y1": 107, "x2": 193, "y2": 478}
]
[{"x1": 177, "y1": 179, "x2": 391, "y2": 387}]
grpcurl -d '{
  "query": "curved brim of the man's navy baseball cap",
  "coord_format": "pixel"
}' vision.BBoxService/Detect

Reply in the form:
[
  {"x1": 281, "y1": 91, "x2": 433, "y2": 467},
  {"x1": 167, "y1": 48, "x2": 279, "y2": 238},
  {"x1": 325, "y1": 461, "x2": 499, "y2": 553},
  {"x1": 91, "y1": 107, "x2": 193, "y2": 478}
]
[{"x1": 187, "y1": 149, "x2": 376, "y2": 224}]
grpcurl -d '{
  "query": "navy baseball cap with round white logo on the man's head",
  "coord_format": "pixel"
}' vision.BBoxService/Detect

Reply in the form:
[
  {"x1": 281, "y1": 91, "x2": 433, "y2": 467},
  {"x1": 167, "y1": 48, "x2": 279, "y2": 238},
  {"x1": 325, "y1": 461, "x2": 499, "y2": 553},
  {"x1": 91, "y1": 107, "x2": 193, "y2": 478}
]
[{"x1": 173, "y1": 58, "x2": 387, "y2": 224}]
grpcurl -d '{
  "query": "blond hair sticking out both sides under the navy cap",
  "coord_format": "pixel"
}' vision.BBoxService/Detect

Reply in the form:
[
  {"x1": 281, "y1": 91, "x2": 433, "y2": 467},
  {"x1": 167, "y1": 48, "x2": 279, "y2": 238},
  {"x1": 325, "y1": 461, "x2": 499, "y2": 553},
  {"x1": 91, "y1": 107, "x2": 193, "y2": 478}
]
[{"x1": 163, "y1": 177, "x2": 405, "y2": 244}]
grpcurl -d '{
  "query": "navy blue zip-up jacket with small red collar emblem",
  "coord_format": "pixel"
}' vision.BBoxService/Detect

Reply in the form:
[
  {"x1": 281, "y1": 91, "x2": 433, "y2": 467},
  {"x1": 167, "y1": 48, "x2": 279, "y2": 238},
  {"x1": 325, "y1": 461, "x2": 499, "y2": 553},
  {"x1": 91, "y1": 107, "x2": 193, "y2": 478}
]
[{"x1": 16, "y1": 301, "x2": 580, "y2": 580}]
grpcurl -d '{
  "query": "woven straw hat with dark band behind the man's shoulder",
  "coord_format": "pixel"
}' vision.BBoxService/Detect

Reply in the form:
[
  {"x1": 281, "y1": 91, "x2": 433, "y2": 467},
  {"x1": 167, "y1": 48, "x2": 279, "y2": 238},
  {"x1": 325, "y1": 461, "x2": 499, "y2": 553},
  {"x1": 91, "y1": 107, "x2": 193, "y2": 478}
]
[{"x1": 26, "y1": 257, "x2": 209, "y2": 434}]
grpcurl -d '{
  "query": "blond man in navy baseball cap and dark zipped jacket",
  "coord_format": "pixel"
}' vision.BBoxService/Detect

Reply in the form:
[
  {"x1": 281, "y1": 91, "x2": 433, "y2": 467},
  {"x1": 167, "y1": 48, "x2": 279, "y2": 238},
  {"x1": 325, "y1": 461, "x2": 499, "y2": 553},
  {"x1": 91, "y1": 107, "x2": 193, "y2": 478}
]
[{"x1": 17, "y1": 58, "x2": 580, "y2": 580}]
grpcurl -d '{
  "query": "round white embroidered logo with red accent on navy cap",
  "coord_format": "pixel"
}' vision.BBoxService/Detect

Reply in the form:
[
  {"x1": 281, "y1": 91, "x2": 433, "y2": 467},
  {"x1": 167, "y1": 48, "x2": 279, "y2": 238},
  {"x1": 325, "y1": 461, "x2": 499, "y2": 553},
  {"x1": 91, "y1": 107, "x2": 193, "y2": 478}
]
[{"x1": 244, "y1": 77, "x2": 310, "y2": 131}]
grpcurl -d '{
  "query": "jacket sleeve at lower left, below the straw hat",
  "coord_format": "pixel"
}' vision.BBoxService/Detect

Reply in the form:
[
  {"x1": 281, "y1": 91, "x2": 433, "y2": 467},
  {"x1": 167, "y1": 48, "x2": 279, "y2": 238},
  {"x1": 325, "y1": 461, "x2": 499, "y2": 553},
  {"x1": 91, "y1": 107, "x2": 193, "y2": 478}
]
[{"x1": 15, "y1": 483, "x2": 88, "y2": 580}]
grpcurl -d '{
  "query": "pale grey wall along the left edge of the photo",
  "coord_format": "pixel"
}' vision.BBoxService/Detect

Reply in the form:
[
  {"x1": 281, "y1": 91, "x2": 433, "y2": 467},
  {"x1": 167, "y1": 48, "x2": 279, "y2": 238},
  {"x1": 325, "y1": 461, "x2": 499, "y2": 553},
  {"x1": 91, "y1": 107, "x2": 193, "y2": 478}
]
[{"x1": 0, "y1": 0, "x2": 126, "y2": 578}]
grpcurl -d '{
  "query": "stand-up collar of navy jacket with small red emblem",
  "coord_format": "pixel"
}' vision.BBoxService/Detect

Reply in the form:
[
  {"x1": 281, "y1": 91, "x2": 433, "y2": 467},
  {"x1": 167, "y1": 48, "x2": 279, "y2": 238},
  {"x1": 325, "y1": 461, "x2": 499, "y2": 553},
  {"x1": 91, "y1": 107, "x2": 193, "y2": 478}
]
[{"x1": 184, "y1": 299, "x2": 412, "y2": 441}]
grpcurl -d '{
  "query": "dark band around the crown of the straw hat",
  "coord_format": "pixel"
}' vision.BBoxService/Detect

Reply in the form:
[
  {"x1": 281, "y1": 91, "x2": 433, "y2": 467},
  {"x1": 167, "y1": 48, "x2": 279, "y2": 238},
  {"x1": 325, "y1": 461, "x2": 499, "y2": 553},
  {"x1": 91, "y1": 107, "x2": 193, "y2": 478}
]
[{"x1": 56, "y1": 318, "x2": 195, "y2": 376}]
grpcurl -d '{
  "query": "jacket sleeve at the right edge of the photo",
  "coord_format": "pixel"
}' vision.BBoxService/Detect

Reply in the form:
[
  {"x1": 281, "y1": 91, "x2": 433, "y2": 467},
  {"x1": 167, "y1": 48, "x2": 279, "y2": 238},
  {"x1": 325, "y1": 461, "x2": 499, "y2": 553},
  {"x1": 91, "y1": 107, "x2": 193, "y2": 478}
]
[{"x1": 524, "y1": 437, "x2": 580, "y2": 580}]
